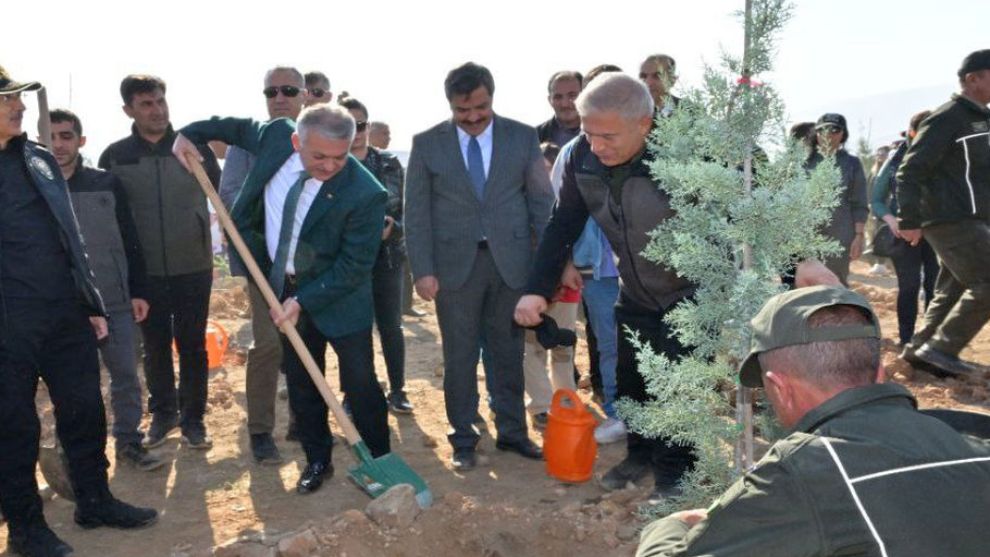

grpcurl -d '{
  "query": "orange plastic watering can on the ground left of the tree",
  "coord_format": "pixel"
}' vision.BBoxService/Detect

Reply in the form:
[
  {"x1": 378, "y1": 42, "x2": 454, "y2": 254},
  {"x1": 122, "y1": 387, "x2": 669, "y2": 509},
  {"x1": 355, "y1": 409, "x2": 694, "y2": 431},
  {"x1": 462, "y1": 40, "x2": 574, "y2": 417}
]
[{"x1": 543, "y1": 389, "x2": 598, "y2": 483}]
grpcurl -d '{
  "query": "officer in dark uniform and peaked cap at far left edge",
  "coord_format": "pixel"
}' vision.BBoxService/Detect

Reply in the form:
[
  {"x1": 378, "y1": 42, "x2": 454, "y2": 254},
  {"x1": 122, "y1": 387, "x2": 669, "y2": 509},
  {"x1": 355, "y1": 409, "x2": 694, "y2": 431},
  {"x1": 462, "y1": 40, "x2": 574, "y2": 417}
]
[{"x1": 0, "y1": 67, "x2": 158, "y2": 557}]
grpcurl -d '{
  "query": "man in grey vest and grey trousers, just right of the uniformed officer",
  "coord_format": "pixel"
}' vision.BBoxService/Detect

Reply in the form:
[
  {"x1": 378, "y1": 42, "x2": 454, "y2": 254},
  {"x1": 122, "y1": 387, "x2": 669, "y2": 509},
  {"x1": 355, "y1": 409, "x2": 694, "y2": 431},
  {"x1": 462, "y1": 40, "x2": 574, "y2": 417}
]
[{"x1": 51, "y1": 106, "x2": 165, "y2": 470}]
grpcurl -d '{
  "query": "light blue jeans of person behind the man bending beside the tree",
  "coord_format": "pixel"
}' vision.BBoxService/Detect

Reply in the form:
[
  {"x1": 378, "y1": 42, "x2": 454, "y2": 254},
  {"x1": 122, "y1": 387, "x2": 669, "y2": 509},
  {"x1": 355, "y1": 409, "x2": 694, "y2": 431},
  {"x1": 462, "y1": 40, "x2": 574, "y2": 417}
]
[{"x1": 581, "y1": 277, "x2": 619, "y2": 418}]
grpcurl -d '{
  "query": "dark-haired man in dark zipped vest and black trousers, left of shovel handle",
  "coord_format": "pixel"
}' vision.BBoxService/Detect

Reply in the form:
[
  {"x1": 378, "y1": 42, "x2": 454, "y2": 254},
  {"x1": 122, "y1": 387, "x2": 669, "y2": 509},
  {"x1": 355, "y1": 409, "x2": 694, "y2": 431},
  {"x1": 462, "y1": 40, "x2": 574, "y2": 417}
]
[{"x1": 99, "y1": 75, "x2": 220, "y2": 449}]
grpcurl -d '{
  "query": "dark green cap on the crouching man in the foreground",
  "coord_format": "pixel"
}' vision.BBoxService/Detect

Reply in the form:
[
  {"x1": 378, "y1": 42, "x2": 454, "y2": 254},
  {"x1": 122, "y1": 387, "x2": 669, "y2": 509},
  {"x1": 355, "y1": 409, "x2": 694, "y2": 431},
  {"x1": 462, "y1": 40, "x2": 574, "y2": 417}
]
[{"x1": 739, "y1": 286, "x2": 880, "y2": 388}]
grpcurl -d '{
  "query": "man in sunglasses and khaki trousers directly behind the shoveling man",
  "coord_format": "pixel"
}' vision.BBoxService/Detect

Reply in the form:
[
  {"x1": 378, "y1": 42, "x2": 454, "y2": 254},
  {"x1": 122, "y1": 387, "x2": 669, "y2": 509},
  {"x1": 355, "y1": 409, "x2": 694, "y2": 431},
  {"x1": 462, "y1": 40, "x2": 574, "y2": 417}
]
[{"x1": 220, "y1": 66, "x2": 308, "y2": 465}]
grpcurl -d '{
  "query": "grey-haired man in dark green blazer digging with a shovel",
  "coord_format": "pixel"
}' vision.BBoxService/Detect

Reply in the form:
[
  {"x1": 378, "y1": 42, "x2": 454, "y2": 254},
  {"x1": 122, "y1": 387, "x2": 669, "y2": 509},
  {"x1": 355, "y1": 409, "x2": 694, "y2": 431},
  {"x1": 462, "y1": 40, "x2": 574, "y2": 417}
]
[{"x1": 173, "y1": 104, "x2": 390, "y2": 494}]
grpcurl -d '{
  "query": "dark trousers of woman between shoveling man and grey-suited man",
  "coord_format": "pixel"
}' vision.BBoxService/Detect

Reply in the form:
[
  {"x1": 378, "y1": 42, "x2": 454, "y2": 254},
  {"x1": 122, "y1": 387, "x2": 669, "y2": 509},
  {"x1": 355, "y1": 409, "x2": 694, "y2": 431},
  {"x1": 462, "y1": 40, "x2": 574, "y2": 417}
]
[{"x1": 371, "y1": 250, "x2": 406, "y2": 393}]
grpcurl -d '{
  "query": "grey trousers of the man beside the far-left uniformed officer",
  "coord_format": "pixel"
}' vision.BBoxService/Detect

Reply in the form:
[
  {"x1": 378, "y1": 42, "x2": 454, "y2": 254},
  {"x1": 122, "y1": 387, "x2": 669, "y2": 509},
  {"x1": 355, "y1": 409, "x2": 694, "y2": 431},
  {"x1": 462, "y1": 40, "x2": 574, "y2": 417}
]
[{"x1": 100, "y1": 309, "x2": 144, "y2": 445}]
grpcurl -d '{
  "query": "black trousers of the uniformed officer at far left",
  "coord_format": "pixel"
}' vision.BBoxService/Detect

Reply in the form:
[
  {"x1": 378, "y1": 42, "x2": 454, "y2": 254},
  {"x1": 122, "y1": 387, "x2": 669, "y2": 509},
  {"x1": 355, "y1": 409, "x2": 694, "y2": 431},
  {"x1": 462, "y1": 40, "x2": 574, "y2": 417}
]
[{"x1": 0, "y1": 298, "x2": 109, "y2": 528}]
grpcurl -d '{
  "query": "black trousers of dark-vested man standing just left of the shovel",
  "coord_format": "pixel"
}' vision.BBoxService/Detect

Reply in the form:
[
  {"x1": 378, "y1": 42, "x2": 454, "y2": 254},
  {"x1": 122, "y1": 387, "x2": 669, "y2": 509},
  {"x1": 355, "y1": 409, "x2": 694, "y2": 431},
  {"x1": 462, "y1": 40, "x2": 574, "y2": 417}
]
[{"x1": 141, "y1": 271, "x2": 213, "y2": 427}]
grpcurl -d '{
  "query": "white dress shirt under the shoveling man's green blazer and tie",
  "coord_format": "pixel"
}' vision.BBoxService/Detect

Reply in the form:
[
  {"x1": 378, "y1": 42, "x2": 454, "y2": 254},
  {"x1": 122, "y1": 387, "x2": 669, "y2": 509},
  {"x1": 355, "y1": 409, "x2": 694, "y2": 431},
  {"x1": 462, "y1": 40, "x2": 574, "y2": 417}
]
[{"x1": 265, "y1": 153, "x2": 323, "y2": 275}]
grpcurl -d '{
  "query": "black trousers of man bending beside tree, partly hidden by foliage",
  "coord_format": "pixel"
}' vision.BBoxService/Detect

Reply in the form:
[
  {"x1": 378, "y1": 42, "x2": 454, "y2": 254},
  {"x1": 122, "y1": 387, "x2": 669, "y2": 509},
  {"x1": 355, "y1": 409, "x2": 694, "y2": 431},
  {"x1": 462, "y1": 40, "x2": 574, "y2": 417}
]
[{"x1": 615, "y1": 297, "x2": 697, "y2": 486}]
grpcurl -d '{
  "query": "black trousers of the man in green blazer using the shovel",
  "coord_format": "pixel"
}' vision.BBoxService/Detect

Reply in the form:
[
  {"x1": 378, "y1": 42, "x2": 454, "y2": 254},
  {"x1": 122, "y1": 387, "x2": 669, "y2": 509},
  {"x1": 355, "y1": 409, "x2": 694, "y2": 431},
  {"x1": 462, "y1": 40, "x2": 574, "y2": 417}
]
[{"x1": 282, "y1": 302, "x2": 391, "y2": 463}]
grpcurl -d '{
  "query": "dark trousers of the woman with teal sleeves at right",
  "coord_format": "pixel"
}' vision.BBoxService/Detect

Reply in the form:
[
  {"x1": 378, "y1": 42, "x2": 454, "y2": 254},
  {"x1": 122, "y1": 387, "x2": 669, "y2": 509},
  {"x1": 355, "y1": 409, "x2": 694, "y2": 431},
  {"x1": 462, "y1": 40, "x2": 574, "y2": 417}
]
[{"x1": 891, "y1": 239, "x2": 939, "y2": 344}]
